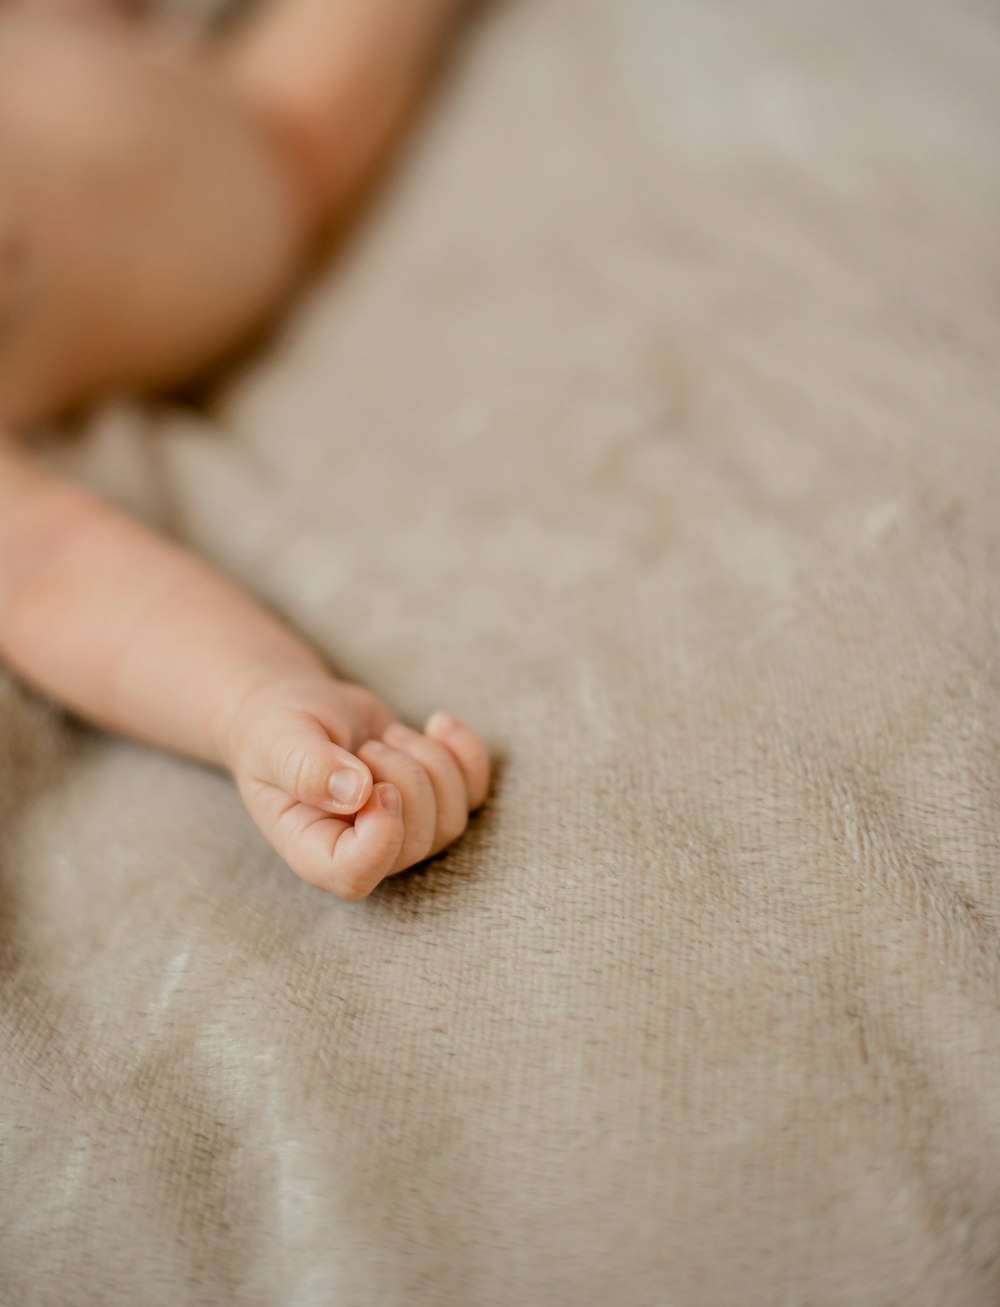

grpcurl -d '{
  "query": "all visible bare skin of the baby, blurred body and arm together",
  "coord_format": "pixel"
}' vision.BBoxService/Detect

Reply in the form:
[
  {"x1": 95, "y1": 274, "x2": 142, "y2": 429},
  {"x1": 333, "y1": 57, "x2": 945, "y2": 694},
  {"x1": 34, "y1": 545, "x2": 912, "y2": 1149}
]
[{"x1": 0, "y1": 0, "x2": 490, "y2": 899}]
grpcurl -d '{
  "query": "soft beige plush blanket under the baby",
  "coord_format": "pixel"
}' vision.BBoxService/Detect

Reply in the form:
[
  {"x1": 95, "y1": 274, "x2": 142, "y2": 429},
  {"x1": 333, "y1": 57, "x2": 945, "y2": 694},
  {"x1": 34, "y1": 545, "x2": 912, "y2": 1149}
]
[{"x1": 0, "y1": 0, "x2": 1000, "y2": 1307}]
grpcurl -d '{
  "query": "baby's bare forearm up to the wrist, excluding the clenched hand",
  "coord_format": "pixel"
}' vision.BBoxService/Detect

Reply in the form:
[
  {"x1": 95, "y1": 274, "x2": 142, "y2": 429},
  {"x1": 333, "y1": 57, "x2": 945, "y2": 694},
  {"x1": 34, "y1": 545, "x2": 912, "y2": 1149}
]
[{"x1": 0, "y1": 438, "x2": 323, "y2": 765}]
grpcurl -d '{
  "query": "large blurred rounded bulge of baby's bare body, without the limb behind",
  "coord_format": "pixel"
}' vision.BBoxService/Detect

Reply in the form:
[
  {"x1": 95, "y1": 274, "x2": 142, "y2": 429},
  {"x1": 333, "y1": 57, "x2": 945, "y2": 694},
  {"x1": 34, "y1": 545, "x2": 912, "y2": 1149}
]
[{"x1": 0, "y1": 9, "x2": 306, "y2": 421}]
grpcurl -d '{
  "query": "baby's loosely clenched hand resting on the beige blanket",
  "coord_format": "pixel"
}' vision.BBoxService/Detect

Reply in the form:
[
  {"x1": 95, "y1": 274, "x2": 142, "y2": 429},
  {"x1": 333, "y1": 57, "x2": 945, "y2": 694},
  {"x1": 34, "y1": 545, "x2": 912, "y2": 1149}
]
[{"x1": 225, "y1": 674, "x2": 490, "y2": 899}]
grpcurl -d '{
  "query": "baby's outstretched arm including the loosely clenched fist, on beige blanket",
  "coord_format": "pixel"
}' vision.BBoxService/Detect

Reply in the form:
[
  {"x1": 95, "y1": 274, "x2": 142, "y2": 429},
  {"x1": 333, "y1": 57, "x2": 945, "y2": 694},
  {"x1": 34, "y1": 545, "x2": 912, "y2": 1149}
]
[{"x1": 0, "y1": 435, "x2": 489, "y2": 898}]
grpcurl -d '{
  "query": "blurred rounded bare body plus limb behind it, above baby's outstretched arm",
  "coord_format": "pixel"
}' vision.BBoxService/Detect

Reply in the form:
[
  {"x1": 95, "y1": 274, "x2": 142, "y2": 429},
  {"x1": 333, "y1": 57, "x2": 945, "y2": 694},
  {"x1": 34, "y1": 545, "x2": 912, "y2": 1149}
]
[{"x1": 0, "y1": 0, "x2": 473, "y2": 421}]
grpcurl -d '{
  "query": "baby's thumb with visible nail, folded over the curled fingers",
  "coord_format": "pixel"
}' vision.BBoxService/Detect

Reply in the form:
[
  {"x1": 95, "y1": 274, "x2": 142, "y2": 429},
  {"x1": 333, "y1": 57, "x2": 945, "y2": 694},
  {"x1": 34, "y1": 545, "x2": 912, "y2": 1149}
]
[{"x1": 250, "y1": 714, "x2": 373, "y2": 816}]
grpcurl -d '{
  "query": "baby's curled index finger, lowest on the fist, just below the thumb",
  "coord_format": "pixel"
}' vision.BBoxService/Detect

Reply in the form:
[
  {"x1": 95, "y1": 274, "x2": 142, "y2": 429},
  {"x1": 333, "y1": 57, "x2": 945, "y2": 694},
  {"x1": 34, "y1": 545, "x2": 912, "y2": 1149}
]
[{"x1": 259, "y1": 786, "x2": 403, "y2": 899}]
